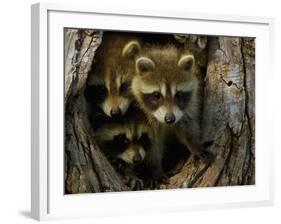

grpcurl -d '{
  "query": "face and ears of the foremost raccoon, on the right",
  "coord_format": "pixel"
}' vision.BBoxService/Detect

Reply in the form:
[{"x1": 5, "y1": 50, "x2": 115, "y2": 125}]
[{"x1": 132, "y1": 55, "x2": 198, "y2": 124}]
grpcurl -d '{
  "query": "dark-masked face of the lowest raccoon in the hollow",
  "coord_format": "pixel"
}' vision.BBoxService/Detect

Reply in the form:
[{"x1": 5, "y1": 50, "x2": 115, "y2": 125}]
[{"x1": 94, "y1": 124, "x2": 151, "y2": 165}]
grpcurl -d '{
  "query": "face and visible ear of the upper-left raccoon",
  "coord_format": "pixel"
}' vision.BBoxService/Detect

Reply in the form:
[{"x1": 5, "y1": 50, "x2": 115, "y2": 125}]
[{"x1": 87, "y1": 41, "x2": 139, "y2": 118}]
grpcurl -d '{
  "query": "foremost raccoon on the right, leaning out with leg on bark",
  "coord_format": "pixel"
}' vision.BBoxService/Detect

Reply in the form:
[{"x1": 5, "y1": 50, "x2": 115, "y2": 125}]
[{"x1": 132, "y1": 45, "x2": 209, "y2": 166}]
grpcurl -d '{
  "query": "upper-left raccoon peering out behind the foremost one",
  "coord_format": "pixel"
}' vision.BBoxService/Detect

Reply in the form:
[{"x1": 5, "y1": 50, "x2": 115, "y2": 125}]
[{"x1": 86, "y1": 32, "x2": 141, "y2": 118}]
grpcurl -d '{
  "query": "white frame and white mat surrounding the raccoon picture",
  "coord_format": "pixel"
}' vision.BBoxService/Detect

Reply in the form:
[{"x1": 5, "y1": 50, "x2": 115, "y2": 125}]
[{"x1": 31, "y1": 3, "x2": 274, "y2": 220}]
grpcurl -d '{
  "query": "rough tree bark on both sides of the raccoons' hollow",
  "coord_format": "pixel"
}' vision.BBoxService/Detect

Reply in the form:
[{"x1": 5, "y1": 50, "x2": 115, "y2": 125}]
[{"x1": 65, "y1": 29, "x2": 255, "y2": 193}]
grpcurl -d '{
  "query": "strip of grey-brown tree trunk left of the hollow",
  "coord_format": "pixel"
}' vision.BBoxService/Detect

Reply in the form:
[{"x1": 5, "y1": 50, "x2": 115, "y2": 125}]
[{"x1": 65, "y1": 29, "x2": 129, "y2": 193}]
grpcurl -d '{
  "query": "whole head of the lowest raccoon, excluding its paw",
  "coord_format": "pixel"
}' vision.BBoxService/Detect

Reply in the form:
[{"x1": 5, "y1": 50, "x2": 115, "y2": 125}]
[{"x1": 95, "y1": 110, "x2": 153, "y2": 165}]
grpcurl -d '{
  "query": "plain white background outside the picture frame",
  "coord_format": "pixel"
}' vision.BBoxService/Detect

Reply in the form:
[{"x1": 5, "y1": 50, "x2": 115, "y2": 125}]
[{"x1": 0, "y1": 0, "x2": 281, "y2": 224}]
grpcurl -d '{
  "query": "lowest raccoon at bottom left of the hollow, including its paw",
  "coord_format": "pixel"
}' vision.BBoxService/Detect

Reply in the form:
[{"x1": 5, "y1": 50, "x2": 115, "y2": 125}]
[{"x1": 95, "y1": 111, "x2": 151, "y2": 188}]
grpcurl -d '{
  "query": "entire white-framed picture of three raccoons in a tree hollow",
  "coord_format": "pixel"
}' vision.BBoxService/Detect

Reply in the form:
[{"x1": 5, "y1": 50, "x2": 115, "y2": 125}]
[{"x1": 31, "y1": 3, "x2": 273, "y2": 220}]
